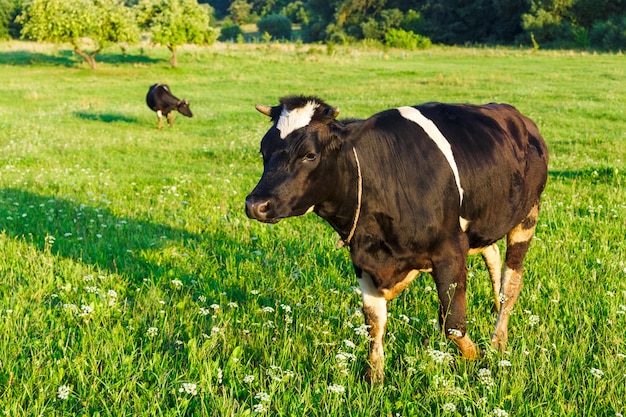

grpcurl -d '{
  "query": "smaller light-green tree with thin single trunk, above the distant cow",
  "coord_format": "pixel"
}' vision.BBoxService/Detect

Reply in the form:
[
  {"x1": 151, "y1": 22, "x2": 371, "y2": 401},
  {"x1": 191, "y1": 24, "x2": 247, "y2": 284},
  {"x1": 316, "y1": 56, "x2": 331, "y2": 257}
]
[{"x1": 137, "y1": 0, "x2": 217, "y2": 67}]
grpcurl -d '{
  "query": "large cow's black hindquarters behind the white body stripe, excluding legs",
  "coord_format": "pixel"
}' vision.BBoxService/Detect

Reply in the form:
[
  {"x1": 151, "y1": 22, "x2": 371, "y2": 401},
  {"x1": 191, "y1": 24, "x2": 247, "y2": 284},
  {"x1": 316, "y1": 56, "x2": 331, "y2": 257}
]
[{"x1": 419, "y1": 103, "x2": 548, "y2": 247}]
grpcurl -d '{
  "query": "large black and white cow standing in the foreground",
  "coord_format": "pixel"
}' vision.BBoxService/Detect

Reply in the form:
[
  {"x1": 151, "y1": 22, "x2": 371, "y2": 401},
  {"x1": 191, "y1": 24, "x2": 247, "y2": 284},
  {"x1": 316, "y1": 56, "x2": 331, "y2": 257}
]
[{"x1": 246, "y1": 96, "x2": 548, "y2": 381}]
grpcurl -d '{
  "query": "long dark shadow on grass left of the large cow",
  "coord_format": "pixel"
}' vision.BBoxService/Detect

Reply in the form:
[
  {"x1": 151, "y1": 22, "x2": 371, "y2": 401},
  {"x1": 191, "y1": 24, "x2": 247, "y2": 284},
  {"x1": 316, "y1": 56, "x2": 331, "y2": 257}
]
[{"x1": 0, "y1": 188, "x2": 242, "y2": 292}]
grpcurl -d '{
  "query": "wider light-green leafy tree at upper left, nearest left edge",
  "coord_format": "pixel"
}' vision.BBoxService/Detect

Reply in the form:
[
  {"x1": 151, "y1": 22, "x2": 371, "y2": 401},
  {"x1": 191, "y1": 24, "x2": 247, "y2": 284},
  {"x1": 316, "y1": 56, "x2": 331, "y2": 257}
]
[{"x1": 16, "y1": 0, "x2": 139, "y2": 69}]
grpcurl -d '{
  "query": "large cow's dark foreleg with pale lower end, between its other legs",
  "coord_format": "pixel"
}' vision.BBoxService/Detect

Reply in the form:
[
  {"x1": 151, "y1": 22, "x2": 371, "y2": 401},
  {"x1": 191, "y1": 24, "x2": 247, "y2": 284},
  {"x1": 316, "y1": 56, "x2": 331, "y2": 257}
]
[{"x1": 433, "y1": 247, "x2": 478, "y2": 359}]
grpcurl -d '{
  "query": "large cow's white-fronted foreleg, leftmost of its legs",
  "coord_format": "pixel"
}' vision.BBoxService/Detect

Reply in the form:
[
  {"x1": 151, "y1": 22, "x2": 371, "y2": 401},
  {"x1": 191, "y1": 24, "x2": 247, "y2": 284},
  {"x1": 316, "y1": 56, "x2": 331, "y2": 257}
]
[{"x1": 357, "y1": 272, "x2": 387, "y2": 383}]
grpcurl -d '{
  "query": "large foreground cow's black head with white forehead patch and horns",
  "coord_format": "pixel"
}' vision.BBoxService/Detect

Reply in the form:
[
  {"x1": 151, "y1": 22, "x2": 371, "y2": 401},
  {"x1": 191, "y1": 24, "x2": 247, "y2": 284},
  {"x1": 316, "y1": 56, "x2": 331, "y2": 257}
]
[{"x1": 246, "y1": 96, "x2": 341, "y2": 223}]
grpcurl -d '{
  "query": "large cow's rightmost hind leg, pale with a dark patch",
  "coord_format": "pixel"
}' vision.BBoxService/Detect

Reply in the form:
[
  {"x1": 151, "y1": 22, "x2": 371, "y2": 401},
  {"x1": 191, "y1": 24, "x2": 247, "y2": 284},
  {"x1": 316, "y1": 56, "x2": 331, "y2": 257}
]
[{"x1": 491, "y1": 203, "x2": 539, "y2": 350}]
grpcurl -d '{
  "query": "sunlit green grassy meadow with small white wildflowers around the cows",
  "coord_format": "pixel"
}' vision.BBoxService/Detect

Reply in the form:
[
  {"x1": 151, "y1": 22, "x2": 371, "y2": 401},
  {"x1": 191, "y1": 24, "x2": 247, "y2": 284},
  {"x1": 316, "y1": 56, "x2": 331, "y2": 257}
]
[{"x1": 0, "y1": 42, "x2": 626, "y2": 417}]
